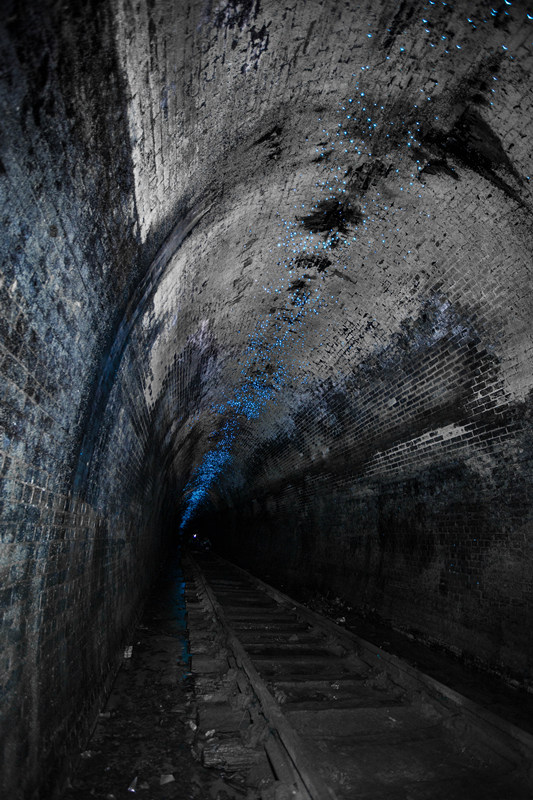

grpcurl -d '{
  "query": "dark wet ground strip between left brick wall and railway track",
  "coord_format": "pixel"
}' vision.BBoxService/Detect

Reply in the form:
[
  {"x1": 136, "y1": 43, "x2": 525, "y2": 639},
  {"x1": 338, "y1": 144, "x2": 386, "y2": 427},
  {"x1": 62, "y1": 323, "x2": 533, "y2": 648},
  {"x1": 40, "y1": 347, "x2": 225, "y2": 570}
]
[{"x1": 62, "y1": 552, "x2": 229, "y2": 800}]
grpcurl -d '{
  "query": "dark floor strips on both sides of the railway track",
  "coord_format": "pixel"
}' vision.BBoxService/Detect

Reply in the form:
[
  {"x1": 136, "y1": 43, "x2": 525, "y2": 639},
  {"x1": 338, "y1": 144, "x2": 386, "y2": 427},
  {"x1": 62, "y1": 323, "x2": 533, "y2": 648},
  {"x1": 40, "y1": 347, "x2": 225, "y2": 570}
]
[{"x1": 61, "y1": 557, "x2": 533, "y2": 800}]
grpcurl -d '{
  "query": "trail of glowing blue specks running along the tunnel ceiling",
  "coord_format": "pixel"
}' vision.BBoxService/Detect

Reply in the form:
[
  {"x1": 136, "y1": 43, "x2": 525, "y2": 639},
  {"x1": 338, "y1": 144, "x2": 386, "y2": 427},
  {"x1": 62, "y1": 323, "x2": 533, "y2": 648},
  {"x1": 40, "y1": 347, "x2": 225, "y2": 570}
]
[{"x1": 182, "y1": 6, "x2": 533, "y2": 528}]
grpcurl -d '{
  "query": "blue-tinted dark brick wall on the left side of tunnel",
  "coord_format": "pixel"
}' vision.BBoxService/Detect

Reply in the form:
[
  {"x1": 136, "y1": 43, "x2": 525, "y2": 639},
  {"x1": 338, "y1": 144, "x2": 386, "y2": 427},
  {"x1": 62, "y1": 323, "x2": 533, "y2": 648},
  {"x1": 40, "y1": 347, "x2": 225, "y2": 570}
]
[{"x1": 0, "y1": 2, "x2": 168, "y2": 798}]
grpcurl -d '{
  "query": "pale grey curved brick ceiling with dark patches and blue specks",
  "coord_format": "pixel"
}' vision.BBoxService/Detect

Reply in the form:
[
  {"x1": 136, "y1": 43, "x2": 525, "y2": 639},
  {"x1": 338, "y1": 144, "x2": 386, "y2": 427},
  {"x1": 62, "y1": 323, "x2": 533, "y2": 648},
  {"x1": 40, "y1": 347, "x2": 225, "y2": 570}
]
[{"x1": 80, "y1": 2, "x2": 533, "y2": 532}]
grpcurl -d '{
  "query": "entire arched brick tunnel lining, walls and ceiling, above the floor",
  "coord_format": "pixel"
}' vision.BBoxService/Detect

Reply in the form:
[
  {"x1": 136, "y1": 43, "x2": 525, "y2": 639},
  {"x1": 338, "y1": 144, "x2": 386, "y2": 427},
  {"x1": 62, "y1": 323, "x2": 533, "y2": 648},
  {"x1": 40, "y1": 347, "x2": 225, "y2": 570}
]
[{"x1": 0, "y1": 0, "x2": 533, "y2": 799}]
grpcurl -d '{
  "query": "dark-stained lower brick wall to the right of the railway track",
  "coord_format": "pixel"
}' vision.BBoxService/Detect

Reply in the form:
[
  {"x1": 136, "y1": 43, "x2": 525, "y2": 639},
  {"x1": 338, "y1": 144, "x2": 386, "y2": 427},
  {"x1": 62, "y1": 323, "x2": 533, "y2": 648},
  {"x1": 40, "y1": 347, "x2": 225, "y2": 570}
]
[{"x1": 211, "y1": 282, "x2": 532, "y2": 685}]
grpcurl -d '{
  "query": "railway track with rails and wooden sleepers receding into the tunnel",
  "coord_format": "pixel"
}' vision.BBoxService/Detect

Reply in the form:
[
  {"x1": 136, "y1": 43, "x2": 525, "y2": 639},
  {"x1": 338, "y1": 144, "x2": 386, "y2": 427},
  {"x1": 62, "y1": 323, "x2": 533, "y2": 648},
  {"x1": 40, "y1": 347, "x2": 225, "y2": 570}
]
[{"x1": 184, "y1": 553, "x2": 533, "y2": 800}]
